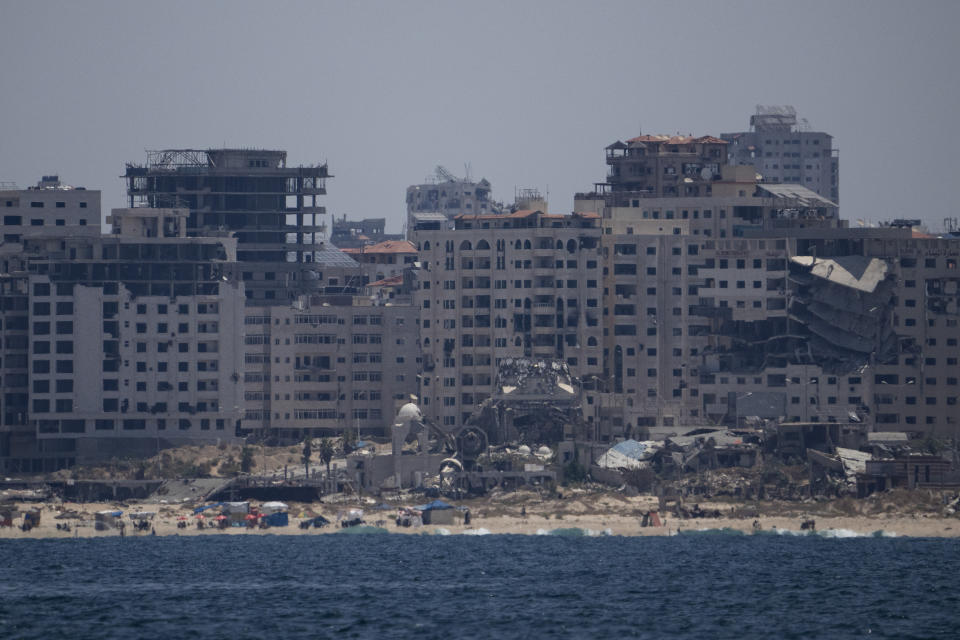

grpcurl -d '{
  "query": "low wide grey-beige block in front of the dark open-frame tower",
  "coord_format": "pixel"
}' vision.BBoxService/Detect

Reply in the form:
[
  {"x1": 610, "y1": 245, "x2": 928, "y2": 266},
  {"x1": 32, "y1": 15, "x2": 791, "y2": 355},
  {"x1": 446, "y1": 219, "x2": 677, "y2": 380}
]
[{"x1": 242, "y1": 278, "x2": 418, "y2": 443}]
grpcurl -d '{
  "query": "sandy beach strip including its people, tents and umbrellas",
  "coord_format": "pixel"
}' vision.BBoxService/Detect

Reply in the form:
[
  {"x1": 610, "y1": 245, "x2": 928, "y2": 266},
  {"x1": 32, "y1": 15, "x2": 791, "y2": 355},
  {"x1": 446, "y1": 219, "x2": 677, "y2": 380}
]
[{"x1": 0, "y1": 496, "x2": 960, "y2": 538}]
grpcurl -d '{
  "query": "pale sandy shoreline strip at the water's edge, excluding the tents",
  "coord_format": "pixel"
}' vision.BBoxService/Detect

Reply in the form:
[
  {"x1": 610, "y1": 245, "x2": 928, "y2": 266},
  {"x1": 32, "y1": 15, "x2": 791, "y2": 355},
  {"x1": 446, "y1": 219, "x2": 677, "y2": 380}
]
[{"x1": 0, "y1": 503, "x2": 960, "y2": 540}]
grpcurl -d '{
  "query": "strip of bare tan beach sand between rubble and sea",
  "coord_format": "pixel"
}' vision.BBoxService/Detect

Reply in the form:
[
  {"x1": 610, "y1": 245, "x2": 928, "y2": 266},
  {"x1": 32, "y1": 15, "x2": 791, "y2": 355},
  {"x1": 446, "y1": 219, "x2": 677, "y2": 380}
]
[{"x1": 0, "y1": 496, "x2": 960, "y2": 539}]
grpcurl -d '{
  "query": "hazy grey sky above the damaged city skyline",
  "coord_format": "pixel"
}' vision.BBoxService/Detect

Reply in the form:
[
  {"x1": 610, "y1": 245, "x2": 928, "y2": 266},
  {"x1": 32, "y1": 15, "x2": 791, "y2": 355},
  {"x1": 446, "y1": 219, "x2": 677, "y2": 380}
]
[{"x1": 0, "y1": 0, "x2": 960, "y2": 231}]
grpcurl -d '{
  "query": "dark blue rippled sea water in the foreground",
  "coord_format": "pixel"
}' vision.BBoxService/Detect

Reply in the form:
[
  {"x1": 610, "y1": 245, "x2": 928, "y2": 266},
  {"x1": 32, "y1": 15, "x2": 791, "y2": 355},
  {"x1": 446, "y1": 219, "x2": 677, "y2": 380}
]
[{"x1": 0, "y1": 531, "x2": 960, "y2": 639}]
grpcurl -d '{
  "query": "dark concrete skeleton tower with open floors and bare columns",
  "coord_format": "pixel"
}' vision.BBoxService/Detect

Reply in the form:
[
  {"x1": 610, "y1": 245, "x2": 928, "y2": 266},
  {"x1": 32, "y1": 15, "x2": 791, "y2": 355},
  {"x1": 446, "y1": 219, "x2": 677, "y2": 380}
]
[{"x1": 124, "y1": 149, "x2": 330, "y2": 305}]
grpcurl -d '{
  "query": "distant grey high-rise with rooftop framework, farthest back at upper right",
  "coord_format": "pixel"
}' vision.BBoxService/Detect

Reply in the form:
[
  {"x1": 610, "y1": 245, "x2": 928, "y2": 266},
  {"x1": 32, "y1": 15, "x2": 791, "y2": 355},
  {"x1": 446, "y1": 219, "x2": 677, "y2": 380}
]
[{"x1": 720, "y1": 106, "x2": 840, "y2": 203}]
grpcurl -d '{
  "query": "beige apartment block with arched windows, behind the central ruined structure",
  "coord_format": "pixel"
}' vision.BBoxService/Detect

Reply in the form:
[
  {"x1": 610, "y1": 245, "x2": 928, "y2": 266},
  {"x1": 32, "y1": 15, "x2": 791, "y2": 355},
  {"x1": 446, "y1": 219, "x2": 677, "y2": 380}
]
[{"x1": 412, "y1": 210, "x2": 603, "y2": 428}]
